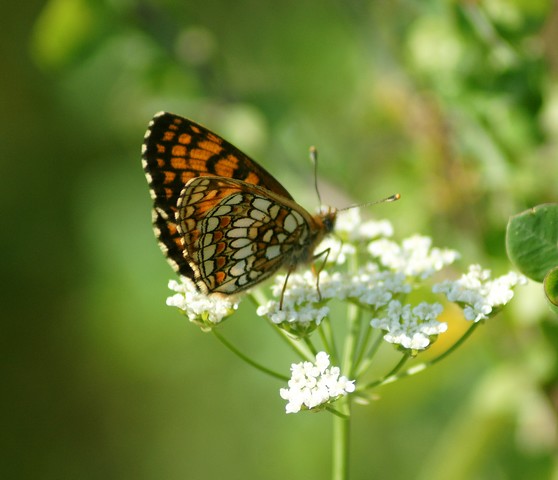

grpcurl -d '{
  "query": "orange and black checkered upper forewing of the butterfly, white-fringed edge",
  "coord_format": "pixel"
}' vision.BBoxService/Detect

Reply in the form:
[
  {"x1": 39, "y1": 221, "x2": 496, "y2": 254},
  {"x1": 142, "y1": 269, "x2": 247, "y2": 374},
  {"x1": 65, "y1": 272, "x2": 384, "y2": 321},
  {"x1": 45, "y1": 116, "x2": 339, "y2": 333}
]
[{"x1": 142, "y1": 112, "x2": 292, "y2": 278}]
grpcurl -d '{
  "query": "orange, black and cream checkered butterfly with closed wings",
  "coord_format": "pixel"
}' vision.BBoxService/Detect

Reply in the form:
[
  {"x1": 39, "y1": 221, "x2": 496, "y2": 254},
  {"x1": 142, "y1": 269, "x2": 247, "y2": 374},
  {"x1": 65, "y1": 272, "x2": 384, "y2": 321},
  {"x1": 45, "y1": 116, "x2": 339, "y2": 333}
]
[{"x1": 142, "y1": 112, "x2": 337, "y2": 299}]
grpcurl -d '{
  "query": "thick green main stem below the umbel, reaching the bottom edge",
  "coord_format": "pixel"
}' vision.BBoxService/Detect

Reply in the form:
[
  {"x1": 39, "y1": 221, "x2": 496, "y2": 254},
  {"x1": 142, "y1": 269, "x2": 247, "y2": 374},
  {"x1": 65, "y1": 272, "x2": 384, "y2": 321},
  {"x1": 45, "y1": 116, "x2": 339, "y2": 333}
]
[{"x1": 331, "y1": 395, "x2": 351, "y2": 480}]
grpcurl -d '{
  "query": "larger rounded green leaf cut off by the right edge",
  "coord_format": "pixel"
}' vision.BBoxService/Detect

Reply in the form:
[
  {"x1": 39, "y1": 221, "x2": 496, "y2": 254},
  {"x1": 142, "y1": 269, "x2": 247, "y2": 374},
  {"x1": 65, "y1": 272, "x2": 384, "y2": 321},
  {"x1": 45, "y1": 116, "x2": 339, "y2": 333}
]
[{"x1": 506, "y1": 203, "x2": 558, "y2": 282}]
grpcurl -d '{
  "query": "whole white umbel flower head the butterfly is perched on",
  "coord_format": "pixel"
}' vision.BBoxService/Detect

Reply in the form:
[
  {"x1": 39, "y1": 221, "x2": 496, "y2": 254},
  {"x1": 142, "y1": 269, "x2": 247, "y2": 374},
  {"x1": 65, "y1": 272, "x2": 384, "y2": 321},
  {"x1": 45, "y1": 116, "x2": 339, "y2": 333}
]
[{"x1": 167, "y1": 210, "x2": 526, "y2": 413}]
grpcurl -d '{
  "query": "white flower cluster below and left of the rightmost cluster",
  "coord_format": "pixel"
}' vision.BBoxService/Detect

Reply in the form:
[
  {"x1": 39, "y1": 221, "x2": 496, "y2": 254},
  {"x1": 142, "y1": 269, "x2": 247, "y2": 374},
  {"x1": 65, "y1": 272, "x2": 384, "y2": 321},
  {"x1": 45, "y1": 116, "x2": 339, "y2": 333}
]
[{"x1": 370, "y1": 300, "x2": 448, "y2": 352}]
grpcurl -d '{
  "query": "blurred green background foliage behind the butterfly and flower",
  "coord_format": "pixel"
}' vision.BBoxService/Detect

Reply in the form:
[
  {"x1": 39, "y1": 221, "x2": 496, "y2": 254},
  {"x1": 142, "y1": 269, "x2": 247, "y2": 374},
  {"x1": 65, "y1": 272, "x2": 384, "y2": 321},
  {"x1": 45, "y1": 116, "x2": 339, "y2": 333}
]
[{"x1": 4, "y1": 0, "x2": 558, "y2": 480}]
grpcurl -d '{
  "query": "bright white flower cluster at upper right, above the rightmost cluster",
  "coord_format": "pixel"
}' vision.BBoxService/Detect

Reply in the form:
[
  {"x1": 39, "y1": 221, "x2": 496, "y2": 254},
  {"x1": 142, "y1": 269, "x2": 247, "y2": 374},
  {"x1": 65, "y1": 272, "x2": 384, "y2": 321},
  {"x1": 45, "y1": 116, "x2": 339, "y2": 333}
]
[{"x1": 368, "y1": 235, "x2": 459, "y2": 280}]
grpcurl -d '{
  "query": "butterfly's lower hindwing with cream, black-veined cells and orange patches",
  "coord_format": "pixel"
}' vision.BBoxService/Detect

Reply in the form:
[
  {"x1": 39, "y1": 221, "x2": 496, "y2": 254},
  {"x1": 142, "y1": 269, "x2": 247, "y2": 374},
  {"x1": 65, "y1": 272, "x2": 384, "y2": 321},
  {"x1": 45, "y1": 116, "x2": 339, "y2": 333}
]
[{"x1": 177, "y1": 177, "x2": 314, "y2": 294}]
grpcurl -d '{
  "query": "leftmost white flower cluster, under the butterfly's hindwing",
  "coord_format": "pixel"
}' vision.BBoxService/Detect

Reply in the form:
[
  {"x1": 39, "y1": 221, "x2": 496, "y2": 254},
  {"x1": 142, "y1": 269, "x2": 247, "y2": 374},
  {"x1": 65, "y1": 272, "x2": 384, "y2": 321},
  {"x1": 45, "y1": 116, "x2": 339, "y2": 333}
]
[{"x1": 167, "y1": 277, "x2": 238, "y2": 328}]
